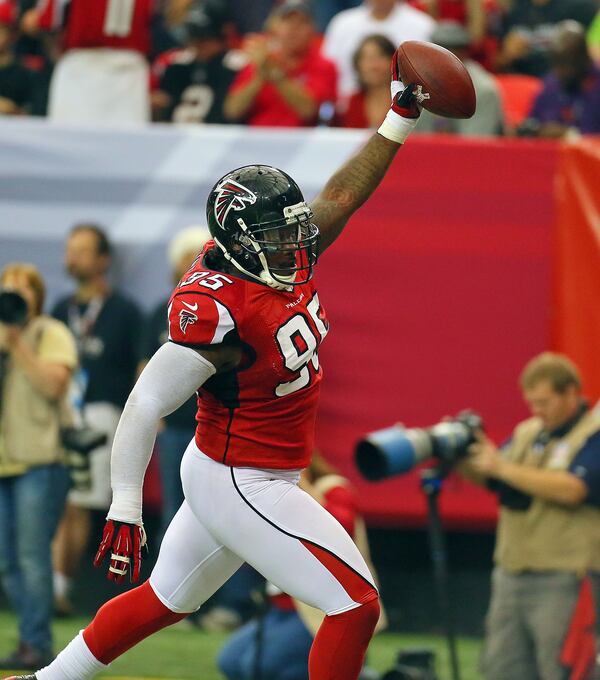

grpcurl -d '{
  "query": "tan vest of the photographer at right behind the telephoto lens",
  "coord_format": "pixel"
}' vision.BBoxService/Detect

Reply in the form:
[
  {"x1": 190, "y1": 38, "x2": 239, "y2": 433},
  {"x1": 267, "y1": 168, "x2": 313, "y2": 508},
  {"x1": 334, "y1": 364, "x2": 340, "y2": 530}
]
[{"x1": 495, "y1": 411, "x2": 600, "y2": 574}]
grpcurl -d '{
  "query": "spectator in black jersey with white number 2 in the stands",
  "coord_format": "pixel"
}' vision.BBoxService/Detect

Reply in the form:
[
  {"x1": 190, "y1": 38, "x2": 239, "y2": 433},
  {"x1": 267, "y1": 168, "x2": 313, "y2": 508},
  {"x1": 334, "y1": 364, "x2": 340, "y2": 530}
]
[{"x1": 152, "y1": 5, "x2": 240, "y2": 123}]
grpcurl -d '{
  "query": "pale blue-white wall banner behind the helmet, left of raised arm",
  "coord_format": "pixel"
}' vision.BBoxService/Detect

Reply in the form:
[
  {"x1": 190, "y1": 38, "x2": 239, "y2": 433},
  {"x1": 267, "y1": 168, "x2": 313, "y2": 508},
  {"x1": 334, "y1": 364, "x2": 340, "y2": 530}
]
[{"x1": 0, "y1": 119, "x2": 368, "y2": 308}]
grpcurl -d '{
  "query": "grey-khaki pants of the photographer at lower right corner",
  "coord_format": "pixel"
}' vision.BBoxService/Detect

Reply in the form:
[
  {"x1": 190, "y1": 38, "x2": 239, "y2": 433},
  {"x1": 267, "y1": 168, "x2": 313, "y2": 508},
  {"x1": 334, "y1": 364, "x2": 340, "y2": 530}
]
[{"x1": 482, "y1": 567, "x2": 581, "y2": 680}]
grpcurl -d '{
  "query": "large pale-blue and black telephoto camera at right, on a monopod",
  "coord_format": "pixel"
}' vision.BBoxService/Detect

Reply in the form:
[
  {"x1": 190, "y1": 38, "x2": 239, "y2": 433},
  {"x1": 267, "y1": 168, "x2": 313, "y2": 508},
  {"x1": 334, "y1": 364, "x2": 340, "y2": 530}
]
[{"x1": 355, "y1": 411, "x2": 483, "y2": 481}]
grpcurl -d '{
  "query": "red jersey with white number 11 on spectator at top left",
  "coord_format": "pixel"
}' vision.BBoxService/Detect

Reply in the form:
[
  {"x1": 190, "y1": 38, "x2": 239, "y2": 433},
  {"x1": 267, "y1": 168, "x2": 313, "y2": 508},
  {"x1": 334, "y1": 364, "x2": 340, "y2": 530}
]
[{"x1": 37, "y1": 0, "x2": 155, "y2": 54}]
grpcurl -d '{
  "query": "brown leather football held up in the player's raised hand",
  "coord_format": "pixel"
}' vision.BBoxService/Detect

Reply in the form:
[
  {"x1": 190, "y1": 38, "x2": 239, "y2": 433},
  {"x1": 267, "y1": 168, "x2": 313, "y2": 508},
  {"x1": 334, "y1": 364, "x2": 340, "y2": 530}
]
[{"x1": 397, "y1": 40, "x2": 476, "y2": 118}]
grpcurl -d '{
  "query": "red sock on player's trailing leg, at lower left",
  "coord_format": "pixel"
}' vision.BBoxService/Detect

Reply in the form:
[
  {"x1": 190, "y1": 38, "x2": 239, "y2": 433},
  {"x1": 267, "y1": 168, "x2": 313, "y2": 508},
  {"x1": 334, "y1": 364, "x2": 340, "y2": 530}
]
[{"x1": 83, "y1": 581, "x2": 187, "y2": 664}]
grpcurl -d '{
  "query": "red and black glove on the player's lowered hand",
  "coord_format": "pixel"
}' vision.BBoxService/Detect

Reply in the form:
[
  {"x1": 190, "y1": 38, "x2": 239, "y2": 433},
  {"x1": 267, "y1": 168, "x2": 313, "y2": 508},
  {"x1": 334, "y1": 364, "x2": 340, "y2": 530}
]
[{"x1": 94, "y1": 519, "x2": 146, "y2": 583}]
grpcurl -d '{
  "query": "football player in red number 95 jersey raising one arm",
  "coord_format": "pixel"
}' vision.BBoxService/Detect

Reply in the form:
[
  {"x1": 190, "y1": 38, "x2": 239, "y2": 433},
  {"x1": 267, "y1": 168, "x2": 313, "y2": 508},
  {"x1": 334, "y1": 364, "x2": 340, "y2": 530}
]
[{"x1": 5, "y1": 50, "x2": 420, "y2": 680}]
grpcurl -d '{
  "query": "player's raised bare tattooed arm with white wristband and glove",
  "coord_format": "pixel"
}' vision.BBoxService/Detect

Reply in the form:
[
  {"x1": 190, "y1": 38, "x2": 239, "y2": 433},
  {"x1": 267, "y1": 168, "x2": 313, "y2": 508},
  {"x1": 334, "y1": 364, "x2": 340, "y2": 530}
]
[{"x1": 311, "y1": 49, "x2": 420, "y2": 254}]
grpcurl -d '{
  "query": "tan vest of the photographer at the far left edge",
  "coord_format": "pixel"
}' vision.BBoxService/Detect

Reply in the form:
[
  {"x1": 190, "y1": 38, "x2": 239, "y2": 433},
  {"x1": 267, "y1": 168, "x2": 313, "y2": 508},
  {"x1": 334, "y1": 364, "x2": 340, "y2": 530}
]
[{"x1": 0, "y1": 316, "x2": 71, "y2": 476}]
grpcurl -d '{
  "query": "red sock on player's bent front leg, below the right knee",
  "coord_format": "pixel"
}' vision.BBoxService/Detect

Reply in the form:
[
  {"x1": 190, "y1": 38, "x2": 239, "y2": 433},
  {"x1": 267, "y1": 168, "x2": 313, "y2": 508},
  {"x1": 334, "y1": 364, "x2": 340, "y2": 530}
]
[{"x1": 308, "y1": 591, "x2": 380, "y2": 680}]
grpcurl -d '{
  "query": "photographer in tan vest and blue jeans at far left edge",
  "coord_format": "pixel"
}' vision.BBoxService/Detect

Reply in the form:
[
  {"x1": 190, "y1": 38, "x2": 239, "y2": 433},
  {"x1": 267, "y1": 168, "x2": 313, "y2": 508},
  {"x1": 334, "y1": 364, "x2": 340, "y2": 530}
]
[{"x1": 0, "y1": 263, "x2": 77, "y2": 669}]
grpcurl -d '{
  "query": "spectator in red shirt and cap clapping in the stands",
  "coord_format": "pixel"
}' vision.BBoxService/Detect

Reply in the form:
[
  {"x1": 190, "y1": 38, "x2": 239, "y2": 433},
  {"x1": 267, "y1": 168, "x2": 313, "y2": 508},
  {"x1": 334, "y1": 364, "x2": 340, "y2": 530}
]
[{"x1": 224, "y1": 0, "x2": 336, "y2": 127}]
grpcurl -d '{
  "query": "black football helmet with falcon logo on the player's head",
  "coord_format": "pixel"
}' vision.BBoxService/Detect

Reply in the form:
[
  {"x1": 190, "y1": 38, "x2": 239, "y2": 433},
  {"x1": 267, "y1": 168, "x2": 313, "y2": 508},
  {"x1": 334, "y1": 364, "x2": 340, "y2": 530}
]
[{"x1": 206, "y1": 165, "x2": 319, "y2": 290}]
